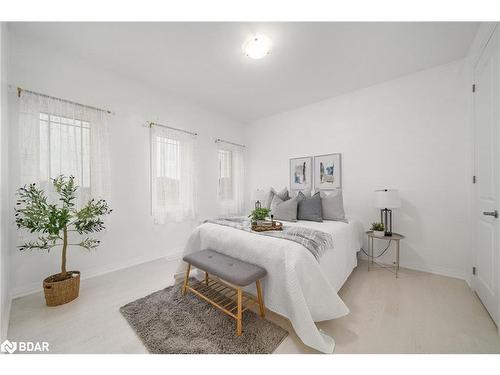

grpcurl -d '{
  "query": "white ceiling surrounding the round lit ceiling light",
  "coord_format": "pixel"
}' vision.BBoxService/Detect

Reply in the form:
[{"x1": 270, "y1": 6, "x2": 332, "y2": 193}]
[{"x1": 9, "y1": 22, "x2": 478, "y2": 122}]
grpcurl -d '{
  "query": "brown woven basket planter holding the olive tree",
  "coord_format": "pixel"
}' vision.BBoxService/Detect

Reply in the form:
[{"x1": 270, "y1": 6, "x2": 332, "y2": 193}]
[{"x1": 43, "y1": 271, "x2": 80, "y2": 306}]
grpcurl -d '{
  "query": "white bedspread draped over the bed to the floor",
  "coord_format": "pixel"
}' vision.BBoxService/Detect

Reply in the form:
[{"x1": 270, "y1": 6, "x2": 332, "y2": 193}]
[{"x1": 179, "y1": 220, "x2": 363, "y2": 353}]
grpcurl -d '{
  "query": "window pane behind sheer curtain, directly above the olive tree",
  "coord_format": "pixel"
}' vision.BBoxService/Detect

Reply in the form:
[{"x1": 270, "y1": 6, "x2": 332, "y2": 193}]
[{"x1": 40, "y1": 113, "x2": 90, "y2": 188}]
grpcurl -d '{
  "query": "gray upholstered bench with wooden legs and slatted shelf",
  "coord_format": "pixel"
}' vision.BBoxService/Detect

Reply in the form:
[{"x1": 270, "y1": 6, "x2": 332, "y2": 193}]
[{"x1": 182, "y1": 250, "x2": 266, "y2": 336}]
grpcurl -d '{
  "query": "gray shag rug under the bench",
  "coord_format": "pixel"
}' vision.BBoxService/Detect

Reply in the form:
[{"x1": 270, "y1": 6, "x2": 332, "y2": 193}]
[{"x1": 120, "y1": 284, "x2": 288, "y2": 354}]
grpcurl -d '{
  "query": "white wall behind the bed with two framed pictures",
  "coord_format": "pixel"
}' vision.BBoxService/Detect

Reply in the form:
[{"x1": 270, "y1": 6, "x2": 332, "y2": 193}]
[{"x1": 247, "y1": 61, "x2": 472, "y2": 279}]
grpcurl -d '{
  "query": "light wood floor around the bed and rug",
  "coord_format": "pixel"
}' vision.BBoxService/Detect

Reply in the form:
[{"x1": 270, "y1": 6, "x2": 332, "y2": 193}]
[{"x1": 8, "y1": 260, "x2": 500, "y2": 353}]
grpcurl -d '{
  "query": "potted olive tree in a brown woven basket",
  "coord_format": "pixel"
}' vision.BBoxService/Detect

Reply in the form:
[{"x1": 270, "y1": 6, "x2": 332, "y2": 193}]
[{"x1": 15, "y1": 176, "x2": 112, "y2": 306}]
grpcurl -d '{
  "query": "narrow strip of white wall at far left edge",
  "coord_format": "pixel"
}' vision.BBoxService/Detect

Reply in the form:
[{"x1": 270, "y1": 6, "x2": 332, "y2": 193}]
[{"x1": 0, "y1": 22, "x2": 10, "y2": 342}]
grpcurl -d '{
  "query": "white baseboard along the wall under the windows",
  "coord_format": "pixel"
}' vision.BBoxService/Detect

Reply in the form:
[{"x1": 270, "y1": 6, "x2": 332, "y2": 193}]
[{"x1": 12, "y1": 249, "x2": 182, "y2": 300}]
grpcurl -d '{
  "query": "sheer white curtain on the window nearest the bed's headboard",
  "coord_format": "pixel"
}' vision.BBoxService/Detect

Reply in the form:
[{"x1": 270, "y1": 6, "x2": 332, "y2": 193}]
[{"x1": 217, "y1": 142, "x2": 245, "y2": 216}]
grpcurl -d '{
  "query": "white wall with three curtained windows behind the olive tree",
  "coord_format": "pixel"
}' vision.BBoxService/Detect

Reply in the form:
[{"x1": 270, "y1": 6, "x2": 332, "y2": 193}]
[{"x1": 9, "y1": 31, "x2": 247, "y2": 295}]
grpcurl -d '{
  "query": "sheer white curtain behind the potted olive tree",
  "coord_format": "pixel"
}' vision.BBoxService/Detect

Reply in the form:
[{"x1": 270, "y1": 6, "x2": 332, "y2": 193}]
[{"x1": 19, "y1": 91, "x2": 109, "y2": 207}]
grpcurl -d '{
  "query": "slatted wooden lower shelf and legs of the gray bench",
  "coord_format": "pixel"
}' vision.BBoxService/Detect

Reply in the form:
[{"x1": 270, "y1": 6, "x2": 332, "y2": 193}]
[{"x1": 182, "y1": 265, "x2": 265, "y2": 336}]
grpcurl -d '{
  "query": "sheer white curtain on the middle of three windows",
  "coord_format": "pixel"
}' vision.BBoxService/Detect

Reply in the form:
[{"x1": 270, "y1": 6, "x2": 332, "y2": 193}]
[{"x1": 151, "y1": 125, "x2": 197, "y2": 224}]
